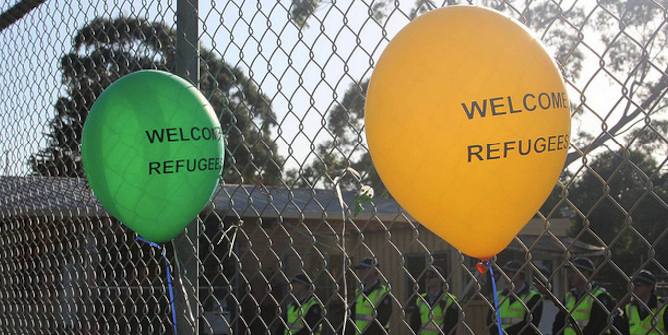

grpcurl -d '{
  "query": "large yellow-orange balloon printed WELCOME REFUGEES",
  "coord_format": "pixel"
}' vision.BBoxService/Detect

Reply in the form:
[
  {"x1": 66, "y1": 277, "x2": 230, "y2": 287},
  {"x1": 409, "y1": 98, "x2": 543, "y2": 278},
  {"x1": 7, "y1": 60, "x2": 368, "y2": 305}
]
[{"x1": 365, "y1": 6, "x2": 571, "y2": 260}]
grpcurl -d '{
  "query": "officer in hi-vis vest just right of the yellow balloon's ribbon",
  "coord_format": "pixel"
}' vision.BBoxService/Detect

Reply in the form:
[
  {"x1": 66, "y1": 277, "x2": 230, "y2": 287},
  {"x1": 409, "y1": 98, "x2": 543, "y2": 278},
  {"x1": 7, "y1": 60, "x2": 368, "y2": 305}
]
[{"x1": 490, "y1": 261, "x2": 543, "y2": 335}]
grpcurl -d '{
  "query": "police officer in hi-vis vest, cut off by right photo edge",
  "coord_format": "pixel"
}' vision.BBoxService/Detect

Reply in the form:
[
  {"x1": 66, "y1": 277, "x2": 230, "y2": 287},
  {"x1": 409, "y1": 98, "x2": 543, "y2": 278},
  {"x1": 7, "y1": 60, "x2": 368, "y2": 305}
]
[{"x1": 626, "y1": 270, "x2": 668, "y2": 335}]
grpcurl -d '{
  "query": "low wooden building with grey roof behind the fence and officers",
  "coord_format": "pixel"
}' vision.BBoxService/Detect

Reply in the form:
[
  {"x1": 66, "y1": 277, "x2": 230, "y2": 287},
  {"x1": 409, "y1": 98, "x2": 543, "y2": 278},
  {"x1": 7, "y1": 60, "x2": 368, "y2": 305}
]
[{"x1": 0, "y1": 177, "x2": 601, "y2": 334}]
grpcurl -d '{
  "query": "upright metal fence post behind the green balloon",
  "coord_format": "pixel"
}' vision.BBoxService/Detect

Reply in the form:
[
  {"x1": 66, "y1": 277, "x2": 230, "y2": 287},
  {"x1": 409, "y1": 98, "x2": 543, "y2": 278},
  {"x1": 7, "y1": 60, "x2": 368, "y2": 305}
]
[{"x1": 174, "y1": 0, "x2": 201, "y2": 335}]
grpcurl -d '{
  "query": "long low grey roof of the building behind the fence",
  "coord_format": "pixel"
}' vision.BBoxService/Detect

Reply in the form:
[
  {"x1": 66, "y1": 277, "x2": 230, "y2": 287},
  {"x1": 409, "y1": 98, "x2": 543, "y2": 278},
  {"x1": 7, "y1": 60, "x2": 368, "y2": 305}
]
[{"x1": 0, "y1": 176, "x2": 410, "y2": 222}]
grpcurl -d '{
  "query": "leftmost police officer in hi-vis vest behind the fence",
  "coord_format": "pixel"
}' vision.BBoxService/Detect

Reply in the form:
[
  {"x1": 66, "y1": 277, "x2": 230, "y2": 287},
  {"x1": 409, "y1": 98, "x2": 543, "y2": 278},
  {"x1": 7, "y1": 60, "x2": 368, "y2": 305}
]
[{"x1": 277, "y1": 273, "x2": 322, "y2": 335}]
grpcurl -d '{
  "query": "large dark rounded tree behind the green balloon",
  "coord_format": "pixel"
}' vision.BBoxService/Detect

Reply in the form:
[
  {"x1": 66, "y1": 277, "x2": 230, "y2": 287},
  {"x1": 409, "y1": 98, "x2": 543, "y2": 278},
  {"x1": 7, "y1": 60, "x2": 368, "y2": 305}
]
[{"x1": 29, "y1": 17, "x2": 283, "y2": 185}]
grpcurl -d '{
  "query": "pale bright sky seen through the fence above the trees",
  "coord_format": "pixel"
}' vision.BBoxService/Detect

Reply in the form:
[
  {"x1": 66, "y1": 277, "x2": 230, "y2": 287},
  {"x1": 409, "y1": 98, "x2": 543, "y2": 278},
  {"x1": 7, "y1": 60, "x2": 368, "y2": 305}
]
[{"x1": 0, "y1": 0, "x2": 656, "y2": 175}]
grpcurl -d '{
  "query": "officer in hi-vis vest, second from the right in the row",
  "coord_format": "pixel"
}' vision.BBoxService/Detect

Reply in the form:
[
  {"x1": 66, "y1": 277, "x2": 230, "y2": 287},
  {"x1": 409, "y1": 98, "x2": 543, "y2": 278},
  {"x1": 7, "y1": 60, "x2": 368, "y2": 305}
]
[{"x1": 552, "y1": 257, "x2": 615, "y2": 335}]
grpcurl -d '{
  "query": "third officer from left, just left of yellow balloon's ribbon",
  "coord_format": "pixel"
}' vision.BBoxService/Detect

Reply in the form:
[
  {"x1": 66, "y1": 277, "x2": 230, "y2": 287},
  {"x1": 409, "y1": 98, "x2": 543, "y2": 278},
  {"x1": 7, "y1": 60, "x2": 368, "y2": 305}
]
[{"x1": 410, "y1": 265, "x2": 459, "y2": 335}]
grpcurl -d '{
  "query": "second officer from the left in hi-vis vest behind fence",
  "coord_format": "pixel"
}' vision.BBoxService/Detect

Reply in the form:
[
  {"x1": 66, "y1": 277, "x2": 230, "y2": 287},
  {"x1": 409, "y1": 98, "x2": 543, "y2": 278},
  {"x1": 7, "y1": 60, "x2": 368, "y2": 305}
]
[{"x1": 346, "y1": 257, "x2": 392, "y2": 335}]
